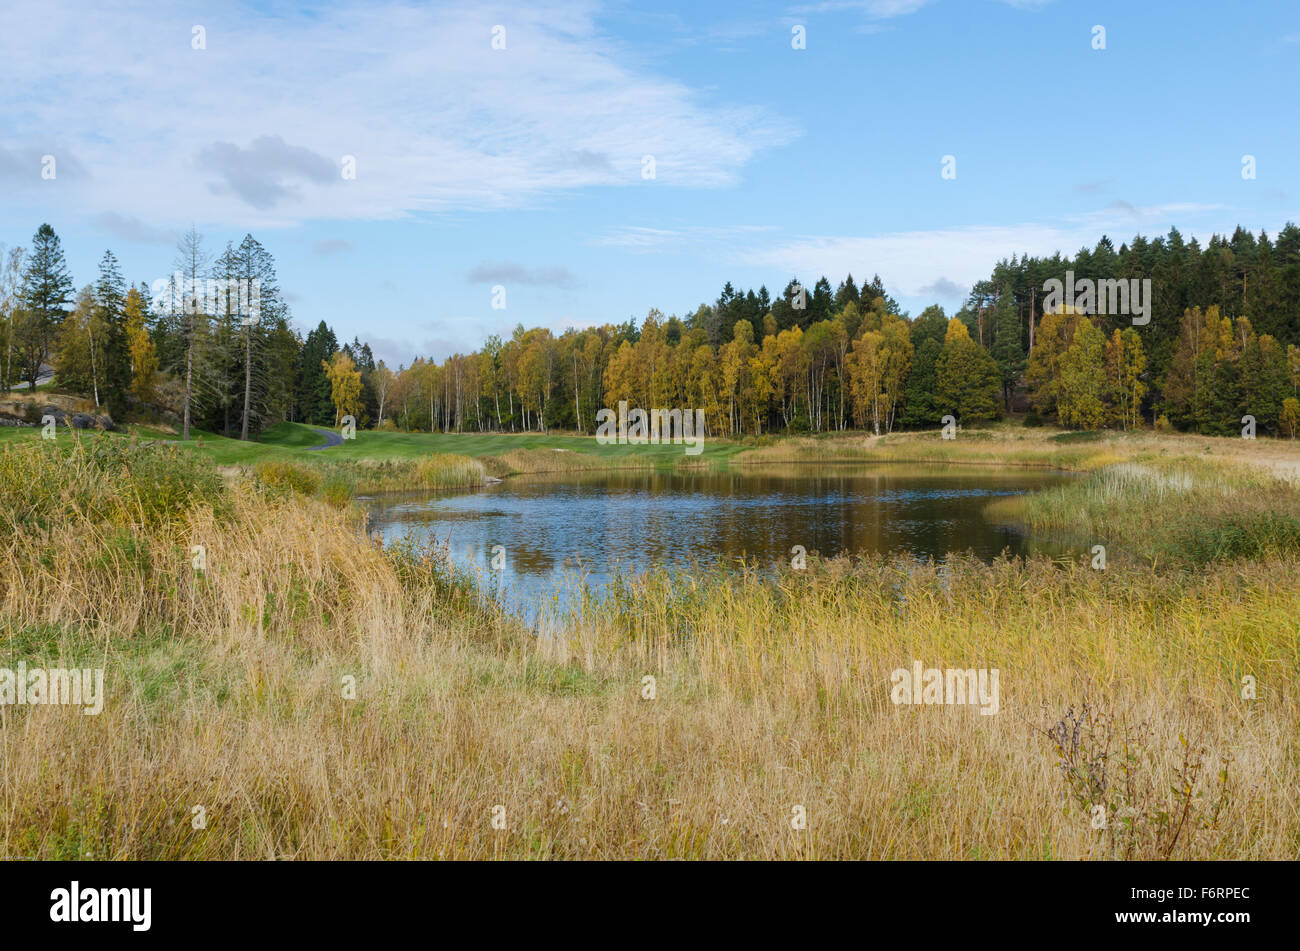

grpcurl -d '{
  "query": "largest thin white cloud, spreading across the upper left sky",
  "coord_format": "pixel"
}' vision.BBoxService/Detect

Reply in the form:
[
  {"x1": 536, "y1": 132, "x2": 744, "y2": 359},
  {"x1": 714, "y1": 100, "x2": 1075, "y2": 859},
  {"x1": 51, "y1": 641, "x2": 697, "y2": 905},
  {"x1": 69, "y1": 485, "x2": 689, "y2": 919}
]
[{"x1": 0, "y1": 0, "x2": 798, "y2": 229}]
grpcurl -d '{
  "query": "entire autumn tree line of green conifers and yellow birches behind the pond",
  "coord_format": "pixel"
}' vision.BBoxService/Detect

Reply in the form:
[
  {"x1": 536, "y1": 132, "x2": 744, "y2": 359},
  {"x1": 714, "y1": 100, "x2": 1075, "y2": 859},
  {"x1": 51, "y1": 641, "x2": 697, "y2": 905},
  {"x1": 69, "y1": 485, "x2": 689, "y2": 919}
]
[{"x1": 0, "y1": 223, "x2": 1300, "y2": 438}]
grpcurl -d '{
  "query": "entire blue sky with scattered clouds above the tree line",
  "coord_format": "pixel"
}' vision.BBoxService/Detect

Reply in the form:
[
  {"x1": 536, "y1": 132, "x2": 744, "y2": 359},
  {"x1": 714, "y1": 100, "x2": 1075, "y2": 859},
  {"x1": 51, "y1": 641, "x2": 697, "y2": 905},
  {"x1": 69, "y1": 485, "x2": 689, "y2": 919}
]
[{"x1": 0, "y1": 0, "x2": 1300, "y2": 365}]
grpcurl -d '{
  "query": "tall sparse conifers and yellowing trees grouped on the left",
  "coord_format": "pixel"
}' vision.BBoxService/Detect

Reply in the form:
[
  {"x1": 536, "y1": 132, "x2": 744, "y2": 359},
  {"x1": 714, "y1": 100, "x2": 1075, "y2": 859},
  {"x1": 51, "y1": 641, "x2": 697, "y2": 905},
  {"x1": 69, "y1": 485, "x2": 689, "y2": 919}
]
[{"x1": 0, "y1": 223, "x2": 377, "y2": 439}]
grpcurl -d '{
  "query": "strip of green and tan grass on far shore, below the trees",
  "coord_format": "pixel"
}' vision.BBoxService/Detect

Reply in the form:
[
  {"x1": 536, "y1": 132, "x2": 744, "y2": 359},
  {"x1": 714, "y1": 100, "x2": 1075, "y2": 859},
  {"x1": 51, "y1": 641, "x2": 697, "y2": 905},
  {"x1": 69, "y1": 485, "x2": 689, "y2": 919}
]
[{"x1": 10, "y1": 422, "x2": 1300, "y2": 491}]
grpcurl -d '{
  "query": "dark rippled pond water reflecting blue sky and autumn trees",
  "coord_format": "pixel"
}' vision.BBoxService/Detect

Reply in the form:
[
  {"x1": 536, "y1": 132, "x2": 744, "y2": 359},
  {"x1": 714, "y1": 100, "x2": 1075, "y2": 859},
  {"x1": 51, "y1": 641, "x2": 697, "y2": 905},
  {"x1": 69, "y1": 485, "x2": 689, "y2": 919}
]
[{"x1": 371, "y1": 466, "x2": 1070, "y2": 615}]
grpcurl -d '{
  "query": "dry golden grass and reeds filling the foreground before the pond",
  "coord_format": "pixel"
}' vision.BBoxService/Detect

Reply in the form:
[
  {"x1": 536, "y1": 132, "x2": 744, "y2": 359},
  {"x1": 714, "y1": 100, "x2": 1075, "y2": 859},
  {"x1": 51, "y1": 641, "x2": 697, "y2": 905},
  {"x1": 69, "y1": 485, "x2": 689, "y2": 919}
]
[{"x1": 0, "y1": 443, "x2": 1300, "y2": 859}]
